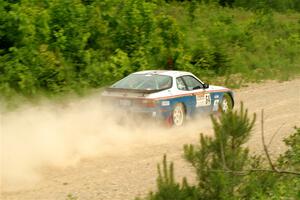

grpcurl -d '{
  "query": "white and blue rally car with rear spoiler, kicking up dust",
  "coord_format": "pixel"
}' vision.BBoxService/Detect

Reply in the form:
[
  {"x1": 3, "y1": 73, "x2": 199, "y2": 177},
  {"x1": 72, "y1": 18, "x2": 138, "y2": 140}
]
[{"x1": 102, "y1": 70, "x2": 234, "y2": 126}]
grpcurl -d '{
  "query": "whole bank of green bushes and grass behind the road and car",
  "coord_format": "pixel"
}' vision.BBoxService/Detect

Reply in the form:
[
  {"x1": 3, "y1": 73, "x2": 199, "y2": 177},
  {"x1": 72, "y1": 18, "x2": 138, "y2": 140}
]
[{"x1": 0, "y1": 0, "x2": 300, "y2": 101}]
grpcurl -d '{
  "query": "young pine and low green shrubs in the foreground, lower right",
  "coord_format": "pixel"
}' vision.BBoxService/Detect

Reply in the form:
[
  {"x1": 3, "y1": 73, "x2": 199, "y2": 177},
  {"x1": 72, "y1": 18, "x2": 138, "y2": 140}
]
[{"x1": 139, "y1": 105, "x2": 300, "y2": 200}]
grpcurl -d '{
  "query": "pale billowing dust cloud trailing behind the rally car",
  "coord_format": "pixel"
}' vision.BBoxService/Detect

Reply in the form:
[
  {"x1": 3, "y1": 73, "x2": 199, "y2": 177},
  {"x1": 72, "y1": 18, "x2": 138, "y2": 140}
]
[{"x1": 0, "y1": 95, "x2": 210, "y2": 191}]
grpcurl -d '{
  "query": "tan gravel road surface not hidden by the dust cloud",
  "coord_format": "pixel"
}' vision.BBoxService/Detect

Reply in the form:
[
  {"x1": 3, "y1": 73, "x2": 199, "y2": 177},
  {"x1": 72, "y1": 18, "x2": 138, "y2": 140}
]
[{"x1": 0, "y1": 79, "x2": 300, "y2": 200}]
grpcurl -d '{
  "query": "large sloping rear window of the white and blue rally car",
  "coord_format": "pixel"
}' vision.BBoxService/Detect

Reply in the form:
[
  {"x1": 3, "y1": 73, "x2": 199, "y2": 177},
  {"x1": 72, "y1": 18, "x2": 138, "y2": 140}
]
[{"x1": 111, "y1": 74, "x2": 172, "y2": 90}]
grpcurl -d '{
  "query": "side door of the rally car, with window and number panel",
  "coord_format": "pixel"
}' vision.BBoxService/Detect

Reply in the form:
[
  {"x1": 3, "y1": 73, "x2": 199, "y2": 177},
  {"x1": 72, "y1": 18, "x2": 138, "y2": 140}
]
[{"x1": 182, "y1": 75, "x2": 212, "y2": 113}]
